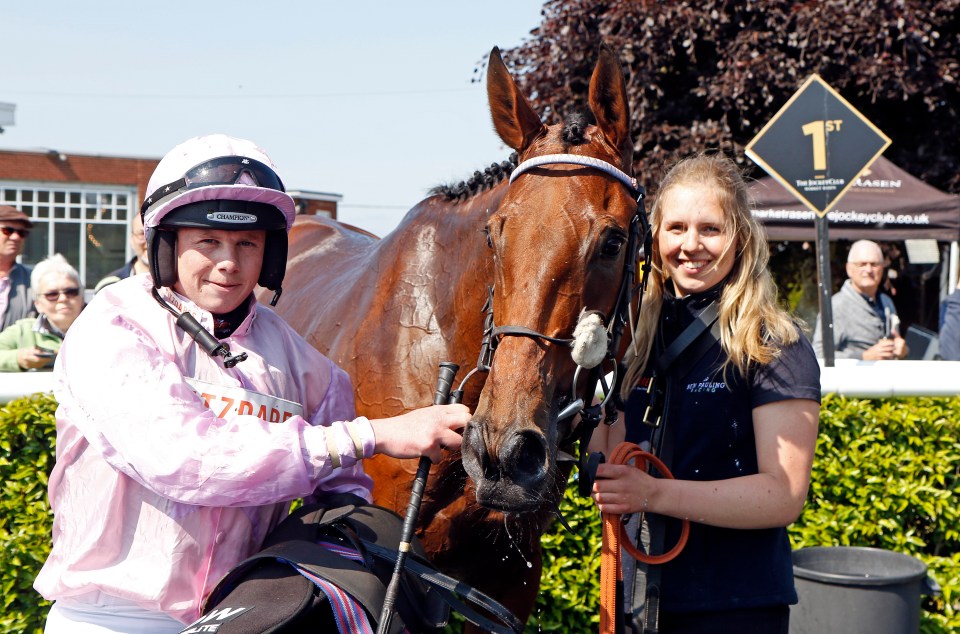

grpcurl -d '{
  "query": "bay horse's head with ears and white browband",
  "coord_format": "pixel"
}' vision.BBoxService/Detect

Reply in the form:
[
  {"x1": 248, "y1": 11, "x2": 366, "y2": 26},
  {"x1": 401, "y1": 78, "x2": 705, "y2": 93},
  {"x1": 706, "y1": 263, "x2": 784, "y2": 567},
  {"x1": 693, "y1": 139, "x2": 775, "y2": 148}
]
[{"x1": 462, "y1": 49, "x2": 637, "y2": 512}]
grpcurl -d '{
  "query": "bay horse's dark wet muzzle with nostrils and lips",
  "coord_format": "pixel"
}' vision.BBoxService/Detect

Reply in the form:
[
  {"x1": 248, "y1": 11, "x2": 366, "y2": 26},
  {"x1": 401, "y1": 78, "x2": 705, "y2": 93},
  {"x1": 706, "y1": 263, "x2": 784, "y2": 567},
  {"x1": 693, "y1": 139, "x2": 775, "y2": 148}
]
[{"x1": 461, "y1": 418, "x2": 550, "y2": 513}]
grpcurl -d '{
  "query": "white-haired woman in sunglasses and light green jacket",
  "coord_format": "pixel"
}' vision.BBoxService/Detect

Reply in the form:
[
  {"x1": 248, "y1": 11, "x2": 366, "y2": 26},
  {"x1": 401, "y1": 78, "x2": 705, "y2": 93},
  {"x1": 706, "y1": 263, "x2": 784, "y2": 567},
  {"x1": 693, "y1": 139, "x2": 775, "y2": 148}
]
[{"x1": 0, "y1": 253, "x2": 84, "y2": 372}]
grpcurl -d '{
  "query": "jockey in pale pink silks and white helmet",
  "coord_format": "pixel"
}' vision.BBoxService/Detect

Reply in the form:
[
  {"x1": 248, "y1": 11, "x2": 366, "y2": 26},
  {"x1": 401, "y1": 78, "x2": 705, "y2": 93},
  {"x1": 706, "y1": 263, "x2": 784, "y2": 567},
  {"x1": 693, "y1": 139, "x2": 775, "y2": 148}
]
[{"x1": 34, "y1": 135, "x2": 469, "y2": 634}]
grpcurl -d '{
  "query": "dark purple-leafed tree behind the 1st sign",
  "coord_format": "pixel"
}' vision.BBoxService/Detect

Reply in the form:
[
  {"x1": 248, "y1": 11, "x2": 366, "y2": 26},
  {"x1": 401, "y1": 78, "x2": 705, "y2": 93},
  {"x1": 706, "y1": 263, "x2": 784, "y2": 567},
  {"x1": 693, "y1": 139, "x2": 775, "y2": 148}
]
[{"x1": 504, "y1": 0, "x2": 960, "y2": 192}]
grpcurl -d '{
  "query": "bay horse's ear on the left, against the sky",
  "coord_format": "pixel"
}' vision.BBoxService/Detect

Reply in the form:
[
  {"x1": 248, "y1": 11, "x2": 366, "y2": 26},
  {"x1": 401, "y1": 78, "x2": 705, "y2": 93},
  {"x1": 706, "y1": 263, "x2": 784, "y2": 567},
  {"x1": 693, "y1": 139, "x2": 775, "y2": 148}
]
[{"x1": 487, "y1": 47, "x2": 546, "y2": 152}]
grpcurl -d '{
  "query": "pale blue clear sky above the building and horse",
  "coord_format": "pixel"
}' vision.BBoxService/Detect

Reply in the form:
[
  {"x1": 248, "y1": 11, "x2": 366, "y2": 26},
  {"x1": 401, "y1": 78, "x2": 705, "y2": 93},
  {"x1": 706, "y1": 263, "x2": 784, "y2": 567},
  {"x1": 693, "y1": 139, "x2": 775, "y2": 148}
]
[{"x1": 0, "y1": 0, "x2": 543, "y2": 236}]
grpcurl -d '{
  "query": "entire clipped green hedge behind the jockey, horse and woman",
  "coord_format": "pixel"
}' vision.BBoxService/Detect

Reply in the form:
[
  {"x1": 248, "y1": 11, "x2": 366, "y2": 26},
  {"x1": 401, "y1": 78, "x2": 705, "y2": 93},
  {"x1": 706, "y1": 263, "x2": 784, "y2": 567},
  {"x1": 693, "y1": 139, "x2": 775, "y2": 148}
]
[{"x1": 0, "y1": 396, "x2": 960, "y2": 634}]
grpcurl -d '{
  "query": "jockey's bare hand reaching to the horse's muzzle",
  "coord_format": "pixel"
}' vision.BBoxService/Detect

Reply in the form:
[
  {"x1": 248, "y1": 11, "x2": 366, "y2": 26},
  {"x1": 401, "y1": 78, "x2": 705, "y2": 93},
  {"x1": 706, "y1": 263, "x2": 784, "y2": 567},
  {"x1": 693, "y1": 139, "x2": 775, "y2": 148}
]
[{"x1": 370, "y1": 404, "x2": 470, "y2": 462}]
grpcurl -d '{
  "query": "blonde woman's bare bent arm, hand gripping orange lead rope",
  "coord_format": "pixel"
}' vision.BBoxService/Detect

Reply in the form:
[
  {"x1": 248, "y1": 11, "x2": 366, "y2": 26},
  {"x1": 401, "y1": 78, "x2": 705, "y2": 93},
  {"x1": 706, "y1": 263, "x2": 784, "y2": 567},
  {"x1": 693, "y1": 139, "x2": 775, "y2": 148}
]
[{"x1": 593, "y1": 399, "x2": 820, "y2": 529}]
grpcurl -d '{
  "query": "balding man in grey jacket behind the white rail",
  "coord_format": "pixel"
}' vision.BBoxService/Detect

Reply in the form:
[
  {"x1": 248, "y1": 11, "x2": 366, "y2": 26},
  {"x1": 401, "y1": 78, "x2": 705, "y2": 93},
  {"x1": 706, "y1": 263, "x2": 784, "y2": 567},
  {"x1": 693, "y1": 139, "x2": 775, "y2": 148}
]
[{"x1": 813, "y1": 240, "x2": 908, "y2": 361}]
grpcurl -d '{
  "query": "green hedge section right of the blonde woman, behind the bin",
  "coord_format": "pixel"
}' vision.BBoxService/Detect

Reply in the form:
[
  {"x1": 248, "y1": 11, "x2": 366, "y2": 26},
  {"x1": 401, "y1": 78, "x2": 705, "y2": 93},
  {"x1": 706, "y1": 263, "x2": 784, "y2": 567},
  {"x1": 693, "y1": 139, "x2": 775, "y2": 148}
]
[{"x1": 790, "y1": 397, "x2": 960, "y2": 634}]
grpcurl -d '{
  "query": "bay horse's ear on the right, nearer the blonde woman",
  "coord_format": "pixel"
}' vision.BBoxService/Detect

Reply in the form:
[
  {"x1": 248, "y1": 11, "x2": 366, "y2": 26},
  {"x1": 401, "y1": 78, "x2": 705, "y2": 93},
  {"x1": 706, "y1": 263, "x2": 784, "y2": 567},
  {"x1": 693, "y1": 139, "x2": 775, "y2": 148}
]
[{"x1": 590, "y1": 46, "x2": 633, "y2": 164}]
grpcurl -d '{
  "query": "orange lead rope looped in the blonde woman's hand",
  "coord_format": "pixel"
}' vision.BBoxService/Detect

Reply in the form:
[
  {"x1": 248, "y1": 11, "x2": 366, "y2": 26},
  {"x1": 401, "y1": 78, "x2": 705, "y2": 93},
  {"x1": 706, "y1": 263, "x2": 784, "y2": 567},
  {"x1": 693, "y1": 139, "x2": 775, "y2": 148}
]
[{"x1": 600, "y1": 442, "x2": 690, "y2": 634}]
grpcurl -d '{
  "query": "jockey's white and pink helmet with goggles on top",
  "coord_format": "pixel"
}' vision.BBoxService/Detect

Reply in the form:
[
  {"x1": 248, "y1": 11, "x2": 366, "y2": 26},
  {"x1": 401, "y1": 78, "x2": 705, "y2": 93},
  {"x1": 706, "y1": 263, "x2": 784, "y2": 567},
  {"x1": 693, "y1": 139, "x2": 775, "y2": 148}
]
[{"x1": 140, "y1": 134, "x2": 296, "y2": 298}]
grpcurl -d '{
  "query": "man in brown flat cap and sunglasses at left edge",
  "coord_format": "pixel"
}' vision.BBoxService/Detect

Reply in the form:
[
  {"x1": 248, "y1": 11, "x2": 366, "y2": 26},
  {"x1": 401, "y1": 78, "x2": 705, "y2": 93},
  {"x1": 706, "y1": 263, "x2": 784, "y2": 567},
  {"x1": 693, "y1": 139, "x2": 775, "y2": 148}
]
[{"x1": 0, "y1": 205, "x2": 36, "y2": 330}]
